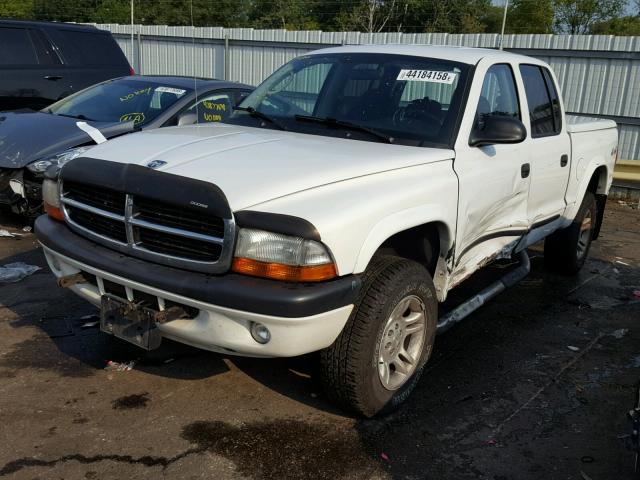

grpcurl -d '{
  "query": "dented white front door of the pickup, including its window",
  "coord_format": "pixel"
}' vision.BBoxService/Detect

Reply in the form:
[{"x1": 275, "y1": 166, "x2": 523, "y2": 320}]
[{"x1": 450, "y1": 62, "x2": 530, "y2": 287}]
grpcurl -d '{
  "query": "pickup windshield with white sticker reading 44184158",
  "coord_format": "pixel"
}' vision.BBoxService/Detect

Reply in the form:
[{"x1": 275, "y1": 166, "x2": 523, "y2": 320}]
[{"x1": 227, "y1": 53, "x2": 469, "y2": 146}]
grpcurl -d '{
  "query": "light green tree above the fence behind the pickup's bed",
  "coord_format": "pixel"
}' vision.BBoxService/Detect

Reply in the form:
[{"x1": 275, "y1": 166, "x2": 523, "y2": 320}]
[{"x1": 554, "y1": 0, "x2": 626, "y2": 34}]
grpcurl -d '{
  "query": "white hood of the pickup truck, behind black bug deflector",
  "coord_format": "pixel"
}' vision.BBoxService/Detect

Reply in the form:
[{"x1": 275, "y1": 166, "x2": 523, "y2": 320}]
[{"x1": 85, "y1": 124, "x2": 455, "y2": 210}]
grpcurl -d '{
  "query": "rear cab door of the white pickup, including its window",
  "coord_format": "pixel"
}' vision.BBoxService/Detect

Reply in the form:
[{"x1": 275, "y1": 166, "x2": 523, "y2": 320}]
[{"x1": 519, "y1": 64, "x2": 571, "y2": 227}]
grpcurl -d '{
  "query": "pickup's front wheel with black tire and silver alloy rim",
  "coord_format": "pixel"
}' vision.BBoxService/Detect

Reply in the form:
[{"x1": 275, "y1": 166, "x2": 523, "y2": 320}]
[{"x1": 320, "y1": 255, "x2": 438, "y2": 417}]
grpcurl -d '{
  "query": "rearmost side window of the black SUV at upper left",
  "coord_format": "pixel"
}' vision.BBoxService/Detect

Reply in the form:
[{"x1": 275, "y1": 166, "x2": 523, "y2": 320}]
[{"x1": 59, "y1": 30, "x2": 124, "y2": 66}]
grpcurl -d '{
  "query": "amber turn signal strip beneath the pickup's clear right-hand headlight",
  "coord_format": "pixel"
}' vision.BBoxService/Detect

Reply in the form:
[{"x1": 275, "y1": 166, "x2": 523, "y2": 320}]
[{"x1": 231, "y1": 258, "x2": 338, "y2": 282}]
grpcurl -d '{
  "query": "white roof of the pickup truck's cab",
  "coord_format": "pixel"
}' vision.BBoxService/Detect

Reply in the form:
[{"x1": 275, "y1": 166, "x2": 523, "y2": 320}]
[{"x1": 309, "y1": 43, "x2": 543, "y2": 65}]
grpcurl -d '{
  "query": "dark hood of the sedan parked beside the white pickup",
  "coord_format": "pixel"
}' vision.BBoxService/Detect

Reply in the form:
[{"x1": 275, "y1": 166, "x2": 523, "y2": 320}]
[{"x1": 0, "y1": 112, "x2": 133, "y2": 168}]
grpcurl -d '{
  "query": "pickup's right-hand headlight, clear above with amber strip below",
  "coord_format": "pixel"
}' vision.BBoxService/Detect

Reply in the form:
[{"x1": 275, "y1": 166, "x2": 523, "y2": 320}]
[{"x1": 232, "y1": 228, "x2": 337, "y2": 282}]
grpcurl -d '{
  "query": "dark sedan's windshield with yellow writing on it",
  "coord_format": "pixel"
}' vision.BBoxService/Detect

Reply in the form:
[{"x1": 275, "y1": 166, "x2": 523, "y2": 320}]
[{"x1": 44, "y1": 79, "x2": 191, "y2": 126}]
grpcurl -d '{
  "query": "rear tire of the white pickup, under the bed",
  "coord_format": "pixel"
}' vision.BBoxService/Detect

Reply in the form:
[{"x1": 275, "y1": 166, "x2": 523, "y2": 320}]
[{"x1": 544, "y1": 192, "x2": 598, "y2": 275}]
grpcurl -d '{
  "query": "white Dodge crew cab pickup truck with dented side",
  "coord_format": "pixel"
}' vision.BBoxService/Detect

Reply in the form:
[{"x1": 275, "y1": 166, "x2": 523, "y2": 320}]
[{"x1": 36, "y1": 45, "x2": 618, "y2": 416}]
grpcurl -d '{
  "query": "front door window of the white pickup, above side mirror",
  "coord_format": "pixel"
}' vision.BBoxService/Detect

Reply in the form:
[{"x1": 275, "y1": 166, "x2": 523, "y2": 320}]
[{"x1": 477, "y1": 64, "x2": 520, "y2": 121}]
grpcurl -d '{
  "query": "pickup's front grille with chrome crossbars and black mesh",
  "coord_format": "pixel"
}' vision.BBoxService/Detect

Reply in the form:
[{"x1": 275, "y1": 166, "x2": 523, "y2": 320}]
[{"x1": 60, "y1": 181, "x2": 235, "y2": 273}]
